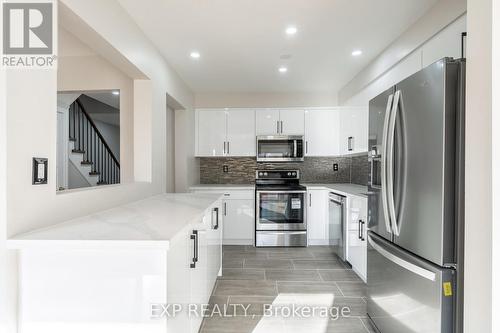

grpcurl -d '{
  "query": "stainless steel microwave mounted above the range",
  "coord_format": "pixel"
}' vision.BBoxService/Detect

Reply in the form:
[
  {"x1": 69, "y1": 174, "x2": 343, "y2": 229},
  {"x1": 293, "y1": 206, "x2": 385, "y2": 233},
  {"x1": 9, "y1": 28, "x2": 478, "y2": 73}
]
[{"x1": 257, "y1": 135, "x2": 304, "y2": 162}]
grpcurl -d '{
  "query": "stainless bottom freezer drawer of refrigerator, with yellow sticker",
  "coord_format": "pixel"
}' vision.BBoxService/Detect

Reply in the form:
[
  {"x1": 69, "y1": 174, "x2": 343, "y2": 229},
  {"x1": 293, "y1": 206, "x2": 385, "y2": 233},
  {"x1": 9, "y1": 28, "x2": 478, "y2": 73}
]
[{"x1": 367, "y1": 232, "x2": 455, "y2": 333}]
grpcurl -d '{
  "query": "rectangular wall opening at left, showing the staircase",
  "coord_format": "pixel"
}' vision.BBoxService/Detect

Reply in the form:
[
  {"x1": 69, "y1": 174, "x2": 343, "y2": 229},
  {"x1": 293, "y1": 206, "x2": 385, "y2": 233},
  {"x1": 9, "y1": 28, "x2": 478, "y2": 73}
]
[{"x1": 56, "y1": 90, "x2": 120, "y2": 191}]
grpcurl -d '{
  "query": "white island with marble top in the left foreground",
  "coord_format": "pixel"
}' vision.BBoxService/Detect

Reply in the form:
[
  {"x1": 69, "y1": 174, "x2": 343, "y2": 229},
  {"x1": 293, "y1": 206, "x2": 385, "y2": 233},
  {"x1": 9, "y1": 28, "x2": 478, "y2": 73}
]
[{"x1": 8, "y1": 194, "x2": 222, "y2": 333}]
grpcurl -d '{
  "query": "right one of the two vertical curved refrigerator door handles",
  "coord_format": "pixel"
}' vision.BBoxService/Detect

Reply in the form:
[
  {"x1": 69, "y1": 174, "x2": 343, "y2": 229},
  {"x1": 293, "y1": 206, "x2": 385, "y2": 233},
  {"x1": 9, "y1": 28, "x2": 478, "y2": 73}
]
[{"x1": 386, "y1": 90, "x2": 401, "y2": 236}]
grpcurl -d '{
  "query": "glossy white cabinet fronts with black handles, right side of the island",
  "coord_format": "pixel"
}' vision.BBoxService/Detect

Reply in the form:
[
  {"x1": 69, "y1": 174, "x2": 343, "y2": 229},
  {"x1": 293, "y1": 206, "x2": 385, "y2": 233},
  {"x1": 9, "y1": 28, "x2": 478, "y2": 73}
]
[{"x1": 167, "y1": 203, "x2": 222, "y2": 333}]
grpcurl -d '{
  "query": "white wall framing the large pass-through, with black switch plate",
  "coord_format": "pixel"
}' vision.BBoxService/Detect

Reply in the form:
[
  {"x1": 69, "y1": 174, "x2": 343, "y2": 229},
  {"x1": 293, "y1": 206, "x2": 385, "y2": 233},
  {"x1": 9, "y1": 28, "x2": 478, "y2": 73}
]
[{"x1": 0, "y1": 0, "x2": 194, "y2": 333}]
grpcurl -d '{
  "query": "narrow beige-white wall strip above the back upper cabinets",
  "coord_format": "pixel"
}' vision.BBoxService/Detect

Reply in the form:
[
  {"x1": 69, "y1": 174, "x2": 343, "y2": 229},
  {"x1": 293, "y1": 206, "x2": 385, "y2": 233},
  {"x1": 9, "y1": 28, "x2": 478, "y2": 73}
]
[{"x1": 195, "y1": 92, "x2": 337, "y2": 108}]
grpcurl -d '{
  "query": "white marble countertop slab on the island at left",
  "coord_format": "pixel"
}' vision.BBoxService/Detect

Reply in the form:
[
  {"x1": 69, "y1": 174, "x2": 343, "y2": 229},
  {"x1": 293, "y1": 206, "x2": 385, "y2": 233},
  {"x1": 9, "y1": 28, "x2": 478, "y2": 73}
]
[{"x1": 7, "y1": 194, "x2": 220, "y2": 249}]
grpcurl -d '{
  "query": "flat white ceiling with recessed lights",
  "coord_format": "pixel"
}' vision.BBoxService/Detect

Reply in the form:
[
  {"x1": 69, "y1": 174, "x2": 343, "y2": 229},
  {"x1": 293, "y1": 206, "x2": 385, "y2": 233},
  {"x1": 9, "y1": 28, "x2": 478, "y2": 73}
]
[{"x1": 119, "y1": 0, "x2": 437, "y2": 93}]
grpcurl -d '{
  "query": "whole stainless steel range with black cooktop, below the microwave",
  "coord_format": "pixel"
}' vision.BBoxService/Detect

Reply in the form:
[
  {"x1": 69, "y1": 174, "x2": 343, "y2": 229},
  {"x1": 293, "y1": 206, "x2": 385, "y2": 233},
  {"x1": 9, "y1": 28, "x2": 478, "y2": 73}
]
[{"x1": 255, "y1": 170, "x2": 307, "y2": 246}]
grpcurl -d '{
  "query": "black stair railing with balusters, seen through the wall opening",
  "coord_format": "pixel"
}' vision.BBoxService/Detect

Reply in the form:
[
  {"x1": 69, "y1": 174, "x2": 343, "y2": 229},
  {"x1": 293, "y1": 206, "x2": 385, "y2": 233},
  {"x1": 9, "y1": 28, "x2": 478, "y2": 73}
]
[{"x1": 69, "y1": 99, "x2": 120, "y2": 185}]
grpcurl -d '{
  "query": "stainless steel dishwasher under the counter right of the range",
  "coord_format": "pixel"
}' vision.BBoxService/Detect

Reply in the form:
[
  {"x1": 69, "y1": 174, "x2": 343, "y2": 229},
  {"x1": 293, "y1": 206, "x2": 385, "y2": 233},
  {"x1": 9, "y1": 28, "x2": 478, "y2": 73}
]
[{"x1": 328, "y1": 193, "x2": 347, "y2": 261}]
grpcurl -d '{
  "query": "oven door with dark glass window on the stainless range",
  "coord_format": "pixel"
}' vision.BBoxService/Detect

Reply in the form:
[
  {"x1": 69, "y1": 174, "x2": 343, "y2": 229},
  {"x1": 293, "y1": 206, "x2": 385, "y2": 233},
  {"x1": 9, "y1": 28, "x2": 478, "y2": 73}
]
[{"x1": 255, "y1": 190, "x2": 307, "y2": 231}]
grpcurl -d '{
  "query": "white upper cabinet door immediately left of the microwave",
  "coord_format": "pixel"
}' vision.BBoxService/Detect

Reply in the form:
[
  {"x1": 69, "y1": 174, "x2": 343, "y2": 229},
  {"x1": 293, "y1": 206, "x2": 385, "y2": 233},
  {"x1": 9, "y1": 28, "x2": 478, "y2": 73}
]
[{"x1": 227, "y1": 110, "x2": 256, "y2": 156}]
